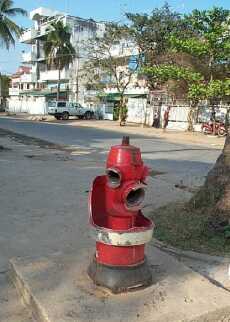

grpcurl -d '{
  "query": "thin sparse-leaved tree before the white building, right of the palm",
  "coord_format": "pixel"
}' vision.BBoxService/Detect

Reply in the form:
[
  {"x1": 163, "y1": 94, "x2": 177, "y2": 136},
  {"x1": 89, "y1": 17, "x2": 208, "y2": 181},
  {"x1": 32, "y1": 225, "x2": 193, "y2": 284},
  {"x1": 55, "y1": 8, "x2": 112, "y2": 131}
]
[{"x1": 85, "y1": 23, "x2": 141, "y2": 125}]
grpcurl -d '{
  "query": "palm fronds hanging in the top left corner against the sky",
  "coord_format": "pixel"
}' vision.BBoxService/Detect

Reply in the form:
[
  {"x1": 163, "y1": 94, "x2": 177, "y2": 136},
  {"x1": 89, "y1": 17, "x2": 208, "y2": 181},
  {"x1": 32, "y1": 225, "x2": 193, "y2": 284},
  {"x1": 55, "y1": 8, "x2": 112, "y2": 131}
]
[{"x1": 0, "y1": 0, "x2": 27, "y2": 49}]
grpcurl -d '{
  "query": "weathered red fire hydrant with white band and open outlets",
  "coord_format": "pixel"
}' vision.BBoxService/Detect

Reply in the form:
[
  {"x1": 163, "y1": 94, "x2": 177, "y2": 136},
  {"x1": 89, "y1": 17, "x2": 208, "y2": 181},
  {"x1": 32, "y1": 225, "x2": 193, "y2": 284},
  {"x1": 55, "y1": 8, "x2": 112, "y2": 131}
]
[{"x1": 88, "y1": 137, "x2": 154, "y2": 293}]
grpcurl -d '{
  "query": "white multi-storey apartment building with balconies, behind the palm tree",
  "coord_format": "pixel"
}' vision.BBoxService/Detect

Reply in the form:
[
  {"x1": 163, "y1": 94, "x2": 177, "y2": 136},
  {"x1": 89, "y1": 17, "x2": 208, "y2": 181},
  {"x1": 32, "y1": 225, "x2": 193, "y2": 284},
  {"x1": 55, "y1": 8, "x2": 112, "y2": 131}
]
[{"x1": 9, "y1": 7, "x2": 105, "y2": 114}]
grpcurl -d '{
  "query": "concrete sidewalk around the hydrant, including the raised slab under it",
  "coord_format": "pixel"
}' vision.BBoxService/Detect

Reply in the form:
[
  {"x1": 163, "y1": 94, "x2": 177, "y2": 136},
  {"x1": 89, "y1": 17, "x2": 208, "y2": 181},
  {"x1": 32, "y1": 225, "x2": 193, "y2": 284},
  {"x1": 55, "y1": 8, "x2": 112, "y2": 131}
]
[{"x1": 0, "y1": 129, "x2": 230, "y2": 322}]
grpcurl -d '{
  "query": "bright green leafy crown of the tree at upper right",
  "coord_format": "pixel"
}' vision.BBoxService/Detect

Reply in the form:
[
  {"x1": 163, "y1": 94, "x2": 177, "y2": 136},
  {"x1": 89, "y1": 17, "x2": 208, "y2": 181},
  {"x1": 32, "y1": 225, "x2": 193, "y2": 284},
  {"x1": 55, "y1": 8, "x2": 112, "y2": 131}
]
[{"x1": 170, "y1": 7, "x2": 230, "y2": 81}]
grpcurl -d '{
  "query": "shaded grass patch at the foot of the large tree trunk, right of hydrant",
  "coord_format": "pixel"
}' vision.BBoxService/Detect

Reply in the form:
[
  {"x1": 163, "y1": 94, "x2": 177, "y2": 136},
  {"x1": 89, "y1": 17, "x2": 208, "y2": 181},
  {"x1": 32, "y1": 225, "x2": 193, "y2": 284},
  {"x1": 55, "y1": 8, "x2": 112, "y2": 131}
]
[{"x1": 151, "y1": 203, "x2": 230, "y2": 255}]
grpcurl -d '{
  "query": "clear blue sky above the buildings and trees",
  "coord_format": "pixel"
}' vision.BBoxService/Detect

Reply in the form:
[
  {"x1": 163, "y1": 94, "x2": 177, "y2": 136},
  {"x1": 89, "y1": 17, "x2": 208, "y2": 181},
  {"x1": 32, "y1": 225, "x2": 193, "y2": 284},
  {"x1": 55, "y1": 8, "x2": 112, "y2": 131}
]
[{"x1": 0, "y1": 0, "x2": 230, "y2": 73}]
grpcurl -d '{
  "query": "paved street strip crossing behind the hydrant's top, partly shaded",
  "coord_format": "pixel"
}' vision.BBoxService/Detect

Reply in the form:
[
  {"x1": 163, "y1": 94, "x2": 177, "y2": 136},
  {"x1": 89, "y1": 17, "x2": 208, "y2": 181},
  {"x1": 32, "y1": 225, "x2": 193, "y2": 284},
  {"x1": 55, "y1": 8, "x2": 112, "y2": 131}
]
[{"x1": 0, "y1": 117, "x2": 220, "y2": 186}]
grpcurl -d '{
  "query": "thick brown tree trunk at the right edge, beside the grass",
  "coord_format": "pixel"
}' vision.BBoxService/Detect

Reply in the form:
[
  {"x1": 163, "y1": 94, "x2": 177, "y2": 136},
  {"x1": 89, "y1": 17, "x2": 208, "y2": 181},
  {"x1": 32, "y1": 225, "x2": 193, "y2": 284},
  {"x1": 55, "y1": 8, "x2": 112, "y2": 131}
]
[{"x1": 190, "y1": 133, "x2": 230, "y2": 220}]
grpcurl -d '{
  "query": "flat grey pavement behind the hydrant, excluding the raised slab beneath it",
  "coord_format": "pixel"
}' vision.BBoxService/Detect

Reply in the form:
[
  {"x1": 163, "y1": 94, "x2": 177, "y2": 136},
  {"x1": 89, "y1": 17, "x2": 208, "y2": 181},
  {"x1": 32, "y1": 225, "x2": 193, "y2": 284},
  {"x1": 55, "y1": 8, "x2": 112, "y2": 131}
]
[{"x1": 0, "y1": 131, "x2": 190, "y2": 322}]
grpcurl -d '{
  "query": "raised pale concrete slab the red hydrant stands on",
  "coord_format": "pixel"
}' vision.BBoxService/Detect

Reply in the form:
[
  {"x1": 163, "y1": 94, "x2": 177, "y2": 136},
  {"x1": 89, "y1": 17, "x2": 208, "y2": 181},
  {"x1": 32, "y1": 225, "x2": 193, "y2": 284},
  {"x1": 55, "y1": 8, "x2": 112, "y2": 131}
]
[{"x1": 10, "y1": 246, "x2": 230, "y2": 322}]
